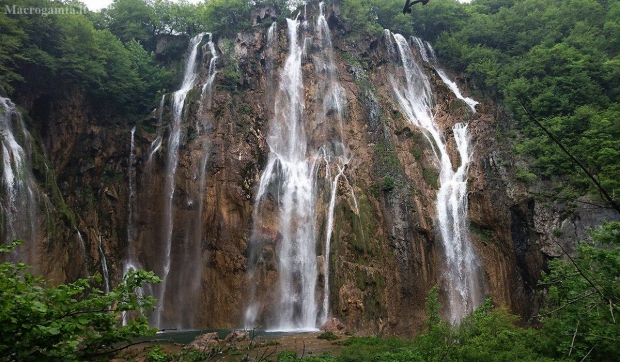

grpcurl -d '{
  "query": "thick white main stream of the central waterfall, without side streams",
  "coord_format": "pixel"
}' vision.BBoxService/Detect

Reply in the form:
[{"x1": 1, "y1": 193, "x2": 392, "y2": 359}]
[{"x1": 255, "y1": 19, "x2": 317, "y2": 330}]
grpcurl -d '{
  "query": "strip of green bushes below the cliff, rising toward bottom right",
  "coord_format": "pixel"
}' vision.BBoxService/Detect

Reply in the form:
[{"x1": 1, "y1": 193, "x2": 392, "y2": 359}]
[{"x1": 128, "y1": 222, "x2": 620, "y2": 362}]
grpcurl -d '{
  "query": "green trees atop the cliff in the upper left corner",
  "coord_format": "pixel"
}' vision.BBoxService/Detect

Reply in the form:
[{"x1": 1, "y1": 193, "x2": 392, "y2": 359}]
[{"x1": 0, "y1": 0, "x2": 170, "y2": 116}]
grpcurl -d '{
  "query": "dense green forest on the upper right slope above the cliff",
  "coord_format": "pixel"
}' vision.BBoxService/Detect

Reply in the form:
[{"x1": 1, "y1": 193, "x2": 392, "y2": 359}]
[{"x1": 432, "y1": 0, "x2": 620, "y2": 201}]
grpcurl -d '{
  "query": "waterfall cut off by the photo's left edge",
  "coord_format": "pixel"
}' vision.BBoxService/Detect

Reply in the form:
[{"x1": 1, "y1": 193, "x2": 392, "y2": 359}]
[{"x1": 0, "y1": 97, "x2": 39, "y2": 265}]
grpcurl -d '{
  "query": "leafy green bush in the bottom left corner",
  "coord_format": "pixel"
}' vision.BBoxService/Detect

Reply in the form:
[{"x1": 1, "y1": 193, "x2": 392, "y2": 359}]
[{"x1": 0, "y1": 242, "x2": 160, "y2": 361}]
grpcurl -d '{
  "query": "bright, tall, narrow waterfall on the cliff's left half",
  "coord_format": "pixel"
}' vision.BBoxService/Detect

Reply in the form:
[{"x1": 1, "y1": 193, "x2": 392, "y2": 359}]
[{"x1": 154, "y1": 33, "x2": 204, "y2": 327}]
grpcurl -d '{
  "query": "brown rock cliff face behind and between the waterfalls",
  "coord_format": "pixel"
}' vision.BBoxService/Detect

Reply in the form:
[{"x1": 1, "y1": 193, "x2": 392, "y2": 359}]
[{"x1": 3, "y1": 5, "x2": 616, "y2": 335}]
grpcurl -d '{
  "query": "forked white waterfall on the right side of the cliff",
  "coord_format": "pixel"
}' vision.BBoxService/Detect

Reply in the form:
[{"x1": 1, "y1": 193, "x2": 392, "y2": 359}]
[{"x1": 390, "y1": 34, "x2": 481, "y2": 323}]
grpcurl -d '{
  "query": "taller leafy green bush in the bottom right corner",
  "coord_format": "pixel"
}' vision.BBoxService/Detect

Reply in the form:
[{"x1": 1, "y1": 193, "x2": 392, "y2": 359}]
[{"x1": 540, "y1": 222, "x2": 620, "y2": 361}]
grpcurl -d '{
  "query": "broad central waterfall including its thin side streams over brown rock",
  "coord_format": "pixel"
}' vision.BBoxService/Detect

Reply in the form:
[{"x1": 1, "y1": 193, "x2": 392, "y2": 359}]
[{"x1": 246, "y1": 3, "x2": 348, "y2": 330}]
